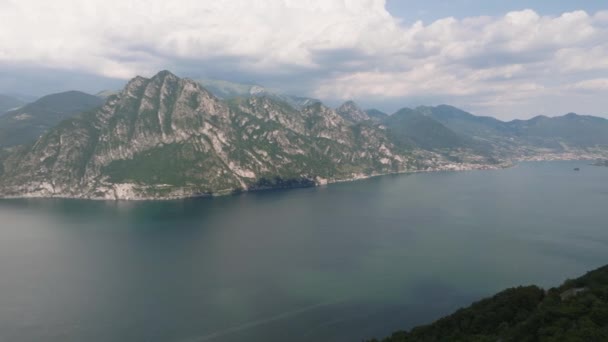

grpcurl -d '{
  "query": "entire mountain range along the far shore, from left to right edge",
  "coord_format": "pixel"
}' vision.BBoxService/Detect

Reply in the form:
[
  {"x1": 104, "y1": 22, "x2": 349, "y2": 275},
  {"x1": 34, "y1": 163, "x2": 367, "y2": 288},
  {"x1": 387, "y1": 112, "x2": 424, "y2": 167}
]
[{"x1": 0, "y1": 71, "x2": 608, "y2": 199}]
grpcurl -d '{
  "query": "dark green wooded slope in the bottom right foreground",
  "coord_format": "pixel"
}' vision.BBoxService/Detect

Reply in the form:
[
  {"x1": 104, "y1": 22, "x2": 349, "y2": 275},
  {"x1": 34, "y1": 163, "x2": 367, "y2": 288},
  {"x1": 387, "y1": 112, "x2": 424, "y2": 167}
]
[{"x1": 370, "y1": 266, "x2": 608, "y2": 342}]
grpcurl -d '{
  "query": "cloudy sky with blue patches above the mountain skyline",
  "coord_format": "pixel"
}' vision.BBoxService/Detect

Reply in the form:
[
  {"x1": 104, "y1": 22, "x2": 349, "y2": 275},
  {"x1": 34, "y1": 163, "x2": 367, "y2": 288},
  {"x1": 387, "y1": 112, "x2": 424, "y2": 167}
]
[{"x1": 0, "y1": 0, "x2": 608, "y2": 120}]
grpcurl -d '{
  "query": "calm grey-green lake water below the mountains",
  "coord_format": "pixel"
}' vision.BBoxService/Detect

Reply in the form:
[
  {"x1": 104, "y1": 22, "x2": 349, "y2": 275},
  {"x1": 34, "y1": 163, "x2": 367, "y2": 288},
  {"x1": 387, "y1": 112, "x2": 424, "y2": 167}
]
[{"x1": 0, "y1": 162, "x2": 608, "y2": 341}]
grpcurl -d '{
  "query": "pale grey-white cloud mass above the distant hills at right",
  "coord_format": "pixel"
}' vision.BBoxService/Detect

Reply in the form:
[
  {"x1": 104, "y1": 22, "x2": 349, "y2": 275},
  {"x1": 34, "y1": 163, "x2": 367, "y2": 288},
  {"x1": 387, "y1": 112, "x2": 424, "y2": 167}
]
[{"x1": 316, "y1": 10, "x2": 608, "y2": 117}]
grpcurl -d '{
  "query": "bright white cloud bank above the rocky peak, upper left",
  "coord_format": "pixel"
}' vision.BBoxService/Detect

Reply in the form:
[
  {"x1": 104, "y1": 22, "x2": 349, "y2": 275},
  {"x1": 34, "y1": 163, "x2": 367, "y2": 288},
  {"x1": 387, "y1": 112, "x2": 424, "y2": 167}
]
[{"x1": 0, "y1": 0, "x2": 398, "y2": 77}]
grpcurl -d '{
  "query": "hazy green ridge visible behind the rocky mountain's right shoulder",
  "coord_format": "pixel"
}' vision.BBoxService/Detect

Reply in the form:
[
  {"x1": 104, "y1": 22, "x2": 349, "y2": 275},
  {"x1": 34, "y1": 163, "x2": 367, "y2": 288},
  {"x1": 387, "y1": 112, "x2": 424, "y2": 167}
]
[{"x1": 197, "y1": 79, "x2": 321, "y2": 109}]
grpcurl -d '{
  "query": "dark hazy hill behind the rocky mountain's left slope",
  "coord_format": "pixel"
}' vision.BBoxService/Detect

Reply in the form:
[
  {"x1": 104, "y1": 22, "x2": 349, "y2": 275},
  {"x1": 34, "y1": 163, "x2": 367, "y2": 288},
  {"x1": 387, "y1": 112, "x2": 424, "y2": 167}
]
[{"x1": 0, "y1": 91, "x2": 103, "y2": 146}]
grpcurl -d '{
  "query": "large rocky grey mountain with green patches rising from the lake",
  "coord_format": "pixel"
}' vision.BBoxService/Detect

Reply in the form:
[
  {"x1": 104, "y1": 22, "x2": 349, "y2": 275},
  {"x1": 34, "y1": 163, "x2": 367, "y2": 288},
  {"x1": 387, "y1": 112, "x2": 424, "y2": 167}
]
[{"x1": 0, "y1": 71, "x2": 476, "y2": 199}]
